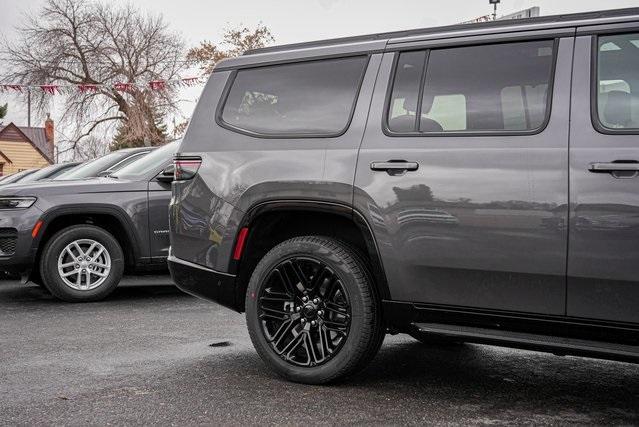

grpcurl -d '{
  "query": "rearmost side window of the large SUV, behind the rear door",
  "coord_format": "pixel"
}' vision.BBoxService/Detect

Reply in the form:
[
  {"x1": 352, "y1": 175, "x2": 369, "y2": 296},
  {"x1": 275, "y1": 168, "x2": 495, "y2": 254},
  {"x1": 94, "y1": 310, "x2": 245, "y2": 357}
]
[{"x1": 221, "y1": 56, "x2": 368, "y2": 136}]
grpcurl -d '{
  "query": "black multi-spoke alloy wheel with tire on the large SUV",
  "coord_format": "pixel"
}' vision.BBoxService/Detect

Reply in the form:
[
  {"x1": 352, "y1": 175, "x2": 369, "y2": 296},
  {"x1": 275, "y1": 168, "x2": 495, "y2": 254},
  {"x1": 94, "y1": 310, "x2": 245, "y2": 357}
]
[{"x1": 245, "y1": 236, "x2": 385, "y2": 384}]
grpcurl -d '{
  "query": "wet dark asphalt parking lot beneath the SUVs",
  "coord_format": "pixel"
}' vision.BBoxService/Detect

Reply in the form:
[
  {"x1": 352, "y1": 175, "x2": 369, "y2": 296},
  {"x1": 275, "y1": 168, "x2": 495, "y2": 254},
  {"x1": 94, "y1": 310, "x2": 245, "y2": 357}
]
[{"x1": 0, "y1": 277, "x2": 639, "y2": 425}]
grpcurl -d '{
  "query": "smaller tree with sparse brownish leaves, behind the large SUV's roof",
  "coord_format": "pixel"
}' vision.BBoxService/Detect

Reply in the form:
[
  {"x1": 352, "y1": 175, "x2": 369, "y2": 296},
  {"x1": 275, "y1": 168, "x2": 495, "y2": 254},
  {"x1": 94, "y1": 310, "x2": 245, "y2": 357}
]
[{"x1": 186, "y1": 24, "x2": 275, "y2": 74}]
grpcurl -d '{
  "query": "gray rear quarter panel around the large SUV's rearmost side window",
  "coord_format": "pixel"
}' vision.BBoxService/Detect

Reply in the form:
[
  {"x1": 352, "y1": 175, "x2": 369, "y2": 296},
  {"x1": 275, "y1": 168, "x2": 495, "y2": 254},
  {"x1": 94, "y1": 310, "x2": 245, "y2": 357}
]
[{"x1": 170, "y1": 54, "x2": 381, "y2": 272}]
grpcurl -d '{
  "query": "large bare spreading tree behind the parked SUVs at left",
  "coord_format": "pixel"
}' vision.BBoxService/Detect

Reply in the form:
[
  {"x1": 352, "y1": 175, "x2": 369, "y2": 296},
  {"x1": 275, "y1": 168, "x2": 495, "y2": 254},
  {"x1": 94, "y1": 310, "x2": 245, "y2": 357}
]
[{"x1": 0, "y1": 0, "x2": 185, "y2": 156}]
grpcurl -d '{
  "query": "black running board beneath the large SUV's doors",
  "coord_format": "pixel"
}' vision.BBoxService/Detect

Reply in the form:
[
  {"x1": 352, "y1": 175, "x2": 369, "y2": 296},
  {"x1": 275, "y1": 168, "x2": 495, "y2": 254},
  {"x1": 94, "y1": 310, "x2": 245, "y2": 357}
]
[{"x1": 412, "y1": 323, "x2": 639, "y2": 363}]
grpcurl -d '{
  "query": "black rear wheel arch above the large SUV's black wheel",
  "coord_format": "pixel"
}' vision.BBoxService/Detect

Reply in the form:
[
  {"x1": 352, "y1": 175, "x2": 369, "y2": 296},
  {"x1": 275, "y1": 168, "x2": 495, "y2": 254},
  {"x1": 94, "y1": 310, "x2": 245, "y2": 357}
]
[{"x1": 228, "y1": 200, "x2": 390, "y2": 311}]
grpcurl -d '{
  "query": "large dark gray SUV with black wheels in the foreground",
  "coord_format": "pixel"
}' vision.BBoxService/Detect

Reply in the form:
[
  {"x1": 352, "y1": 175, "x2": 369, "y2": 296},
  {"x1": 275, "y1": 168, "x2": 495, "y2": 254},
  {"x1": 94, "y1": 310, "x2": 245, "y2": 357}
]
[{"x1": 169, "y1": 9, "x2": 639, "y2": 383}]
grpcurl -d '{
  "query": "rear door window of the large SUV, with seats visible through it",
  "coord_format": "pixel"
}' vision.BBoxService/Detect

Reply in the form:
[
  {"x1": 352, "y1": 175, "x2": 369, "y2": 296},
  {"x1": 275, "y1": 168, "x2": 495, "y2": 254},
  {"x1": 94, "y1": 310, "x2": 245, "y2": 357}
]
[{"x1": 388, "y1": 40, "x2": 554, "y2": 134}]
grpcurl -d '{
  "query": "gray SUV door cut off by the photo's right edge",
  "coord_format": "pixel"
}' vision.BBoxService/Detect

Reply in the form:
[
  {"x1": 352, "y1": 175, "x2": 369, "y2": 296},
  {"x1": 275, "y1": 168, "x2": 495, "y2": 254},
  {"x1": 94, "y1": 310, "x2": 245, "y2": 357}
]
[{"x1": 567, "y1": 27, "x2": 639, "y2": 323}]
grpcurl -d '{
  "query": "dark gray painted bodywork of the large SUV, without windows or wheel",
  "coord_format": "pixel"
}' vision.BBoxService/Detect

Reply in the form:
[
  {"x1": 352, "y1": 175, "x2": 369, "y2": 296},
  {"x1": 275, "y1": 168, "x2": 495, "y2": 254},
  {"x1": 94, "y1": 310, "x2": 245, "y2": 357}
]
[{"x1": 170, "y1": 10, "x2": 639, "y2": 332}]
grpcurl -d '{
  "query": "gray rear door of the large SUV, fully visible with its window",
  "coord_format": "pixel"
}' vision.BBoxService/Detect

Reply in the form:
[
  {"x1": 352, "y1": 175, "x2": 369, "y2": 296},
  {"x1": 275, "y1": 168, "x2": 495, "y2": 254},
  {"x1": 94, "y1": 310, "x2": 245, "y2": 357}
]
[{"x1": 355, "y1": 33, "x2": 574, "y2": 315}]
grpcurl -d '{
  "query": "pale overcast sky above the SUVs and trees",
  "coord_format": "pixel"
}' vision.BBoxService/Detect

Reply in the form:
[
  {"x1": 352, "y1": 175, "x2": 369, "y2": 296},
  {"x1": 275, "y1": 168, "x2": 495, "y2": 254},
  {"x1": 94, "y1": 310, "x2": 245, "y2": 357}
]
[{"x1": 0, "y1": 0, "x2": 639, "y2": 132}]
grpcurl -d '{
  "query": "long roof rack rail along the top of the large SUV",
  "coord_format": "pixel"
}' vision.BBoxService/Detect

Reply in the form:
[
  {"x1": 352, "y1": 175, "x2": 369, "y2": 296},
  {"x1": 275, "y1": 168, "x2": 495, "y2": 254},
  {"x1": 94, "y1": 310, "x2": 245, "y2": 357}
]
[{"x1": 244, "y1": 7, "x2": 639, "y2": 55}]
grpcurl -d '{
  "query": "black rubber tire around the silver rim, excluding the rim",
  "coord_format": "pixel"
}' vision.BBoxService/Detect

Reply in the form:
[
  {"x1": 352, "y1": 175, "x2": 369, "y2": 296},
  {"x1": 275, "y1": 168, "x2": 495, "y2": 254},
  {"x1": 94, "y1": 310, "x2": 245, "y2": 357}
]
[{"x1": 40, "y1": 225, "x2": 124, "y2": 302}]
